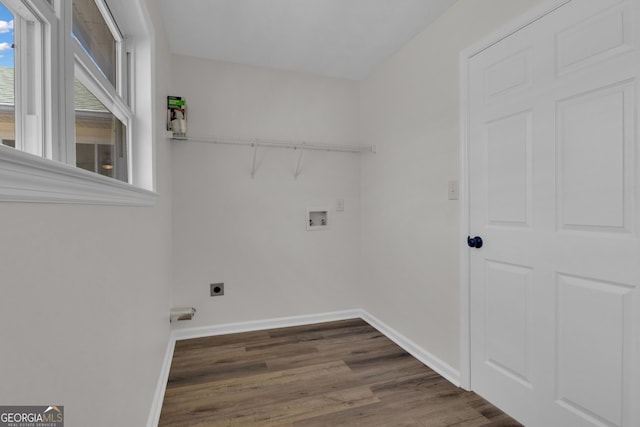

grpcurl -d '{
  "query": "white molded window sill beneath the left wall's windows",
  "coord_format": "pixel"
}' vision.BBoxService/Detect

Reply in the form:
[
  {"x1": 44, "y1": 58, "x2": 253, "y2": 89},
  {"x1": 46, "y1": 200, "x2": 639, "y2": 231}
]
[{"x1": 0, "y1": 146, "x2": 158, "y2": 206}]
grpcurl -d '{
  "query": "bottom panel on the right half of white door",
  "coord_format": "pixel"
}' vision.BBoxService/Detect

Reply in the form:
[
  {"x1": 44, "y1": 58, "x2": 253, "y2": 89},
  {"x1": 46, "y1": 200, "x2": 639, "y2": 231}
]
[{"x1": 556, "y1": 274, "x2": 633, "y2": 426}]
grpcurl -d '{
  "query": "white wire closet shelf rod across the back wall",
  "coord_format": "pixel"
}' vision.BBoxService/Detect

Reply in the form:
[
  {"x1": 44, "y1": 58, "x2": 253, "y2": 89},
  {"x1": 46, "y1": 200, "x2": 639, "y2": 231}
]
[{"x1": 171, "y1": 136, "x2": 376, "y2": 153}]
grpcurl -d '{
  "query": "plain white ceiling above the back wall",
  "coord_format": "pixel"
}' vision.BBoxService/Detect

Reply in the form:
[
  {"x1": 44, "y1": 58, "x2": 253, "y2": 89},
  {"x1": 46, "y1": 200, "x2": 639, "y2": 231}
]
[{"x1": 159, "y1": 0, "x2": 456, "y2": 80}]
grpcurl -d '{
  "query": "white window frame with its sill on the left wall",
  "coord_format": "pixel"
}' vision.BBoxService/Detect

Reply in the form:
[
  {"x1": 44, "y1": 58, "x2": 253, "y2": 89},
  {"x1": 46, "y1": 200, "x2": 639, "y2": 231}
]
[{"x1": 0, "y1": 0, "x2": 158, "y2": 206}]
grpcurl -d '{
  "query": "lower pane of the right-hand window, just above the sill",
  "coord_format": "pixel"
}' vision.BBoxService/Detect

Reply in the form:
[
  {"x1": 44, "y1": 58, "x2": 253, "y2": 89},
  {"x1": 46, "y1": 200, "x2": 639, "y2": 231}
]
[{"x1": 74, "y1": 79, "x2": 128, "y2": 182}]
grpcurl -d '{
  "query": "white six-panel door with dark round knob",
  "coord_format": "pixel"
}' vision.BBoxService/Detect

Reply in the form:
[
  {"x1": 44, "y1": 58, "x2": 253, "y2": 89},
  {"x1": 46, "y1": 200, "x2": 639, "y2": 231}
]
[{"x1": 468, "y1": 0, "x2": 640, "y2": 427}]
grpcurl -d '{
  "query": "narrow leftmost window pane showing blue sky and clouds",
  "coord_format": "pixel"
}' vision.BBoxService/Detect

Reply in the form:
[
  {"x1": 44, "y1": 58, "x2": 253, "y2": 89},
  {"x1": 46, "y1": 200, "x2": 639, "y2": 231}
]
[{"x1": 0, "y1": 2, "x2": 16, "y2": 147}]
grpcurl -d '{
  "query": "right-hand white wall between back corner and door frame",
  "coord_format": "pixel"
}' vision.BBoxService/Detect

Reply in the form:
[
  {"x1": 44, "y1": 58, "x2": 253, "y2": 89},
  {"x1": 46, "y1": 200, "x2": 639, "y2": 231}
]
[{"x1": 360, "y1": 0, "x2": 539, "y2": 369}]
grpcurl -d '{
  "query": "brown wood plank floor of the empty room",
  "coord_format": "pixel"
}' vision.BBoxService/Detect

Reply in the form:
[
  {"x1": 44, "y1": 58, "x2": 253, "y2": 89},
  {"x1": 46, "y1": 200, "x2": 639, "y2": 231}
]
[{"x1": 159, "y1": 319, "x2": 521, "y2": 427}]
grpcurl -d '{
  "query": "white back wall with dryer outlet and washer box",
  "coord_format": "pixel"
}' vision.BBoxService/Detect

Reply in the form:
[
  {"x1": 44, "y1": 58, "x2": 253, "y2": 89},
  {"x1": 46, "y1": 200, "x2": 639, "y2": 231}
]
[{"x1": 172, "y1": 56, "x2": 360, "y2": 328}]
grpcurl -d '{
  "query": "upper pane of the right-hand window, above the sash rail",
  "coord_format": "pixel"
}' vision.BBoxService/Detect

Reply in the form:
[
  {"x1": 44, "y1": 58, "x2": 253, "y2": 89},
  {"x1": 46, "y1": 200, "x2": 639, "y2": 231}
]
[{"x1": 73, "y1": 0, "x2": 116, "y2": 87}]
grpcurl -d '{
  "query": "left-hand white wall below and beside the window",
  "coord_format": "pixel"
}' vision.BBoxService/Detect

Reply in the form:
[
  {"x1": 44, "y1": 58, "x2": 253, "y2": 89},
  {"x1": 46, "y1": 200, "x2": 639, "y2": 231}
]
[{"x1": 0, "y1": 2, "x2": 172, "y2": 427}]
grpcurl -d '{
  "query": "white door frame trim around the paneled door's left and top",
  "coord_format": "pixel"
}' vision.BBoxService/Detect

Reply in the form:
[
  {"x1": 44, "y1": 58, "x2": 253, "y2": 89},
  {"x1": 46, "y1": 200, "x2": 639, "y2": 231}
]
[{"x1": 459, "y1": 0, "x2": 573, "y2": 390}]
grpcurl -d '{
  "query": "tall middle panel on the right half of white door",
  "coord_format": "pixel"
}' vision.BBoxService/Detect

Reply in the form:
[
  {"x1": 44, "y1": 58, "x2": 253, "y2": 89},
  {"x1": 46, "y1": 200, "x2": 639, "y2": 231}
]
[{"x1": 556, "y1": 82, "x2": 635, "y2": 232}]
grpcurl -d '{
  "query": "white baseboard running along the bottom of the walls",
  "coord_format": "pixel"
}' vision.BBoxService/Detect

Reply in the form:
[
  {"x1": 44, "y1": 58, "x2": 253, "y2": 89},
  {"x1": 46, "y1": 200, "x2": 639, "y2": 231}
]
[{"x1": 147, "y1": 309, "x2": 460, "y2": 427}]
